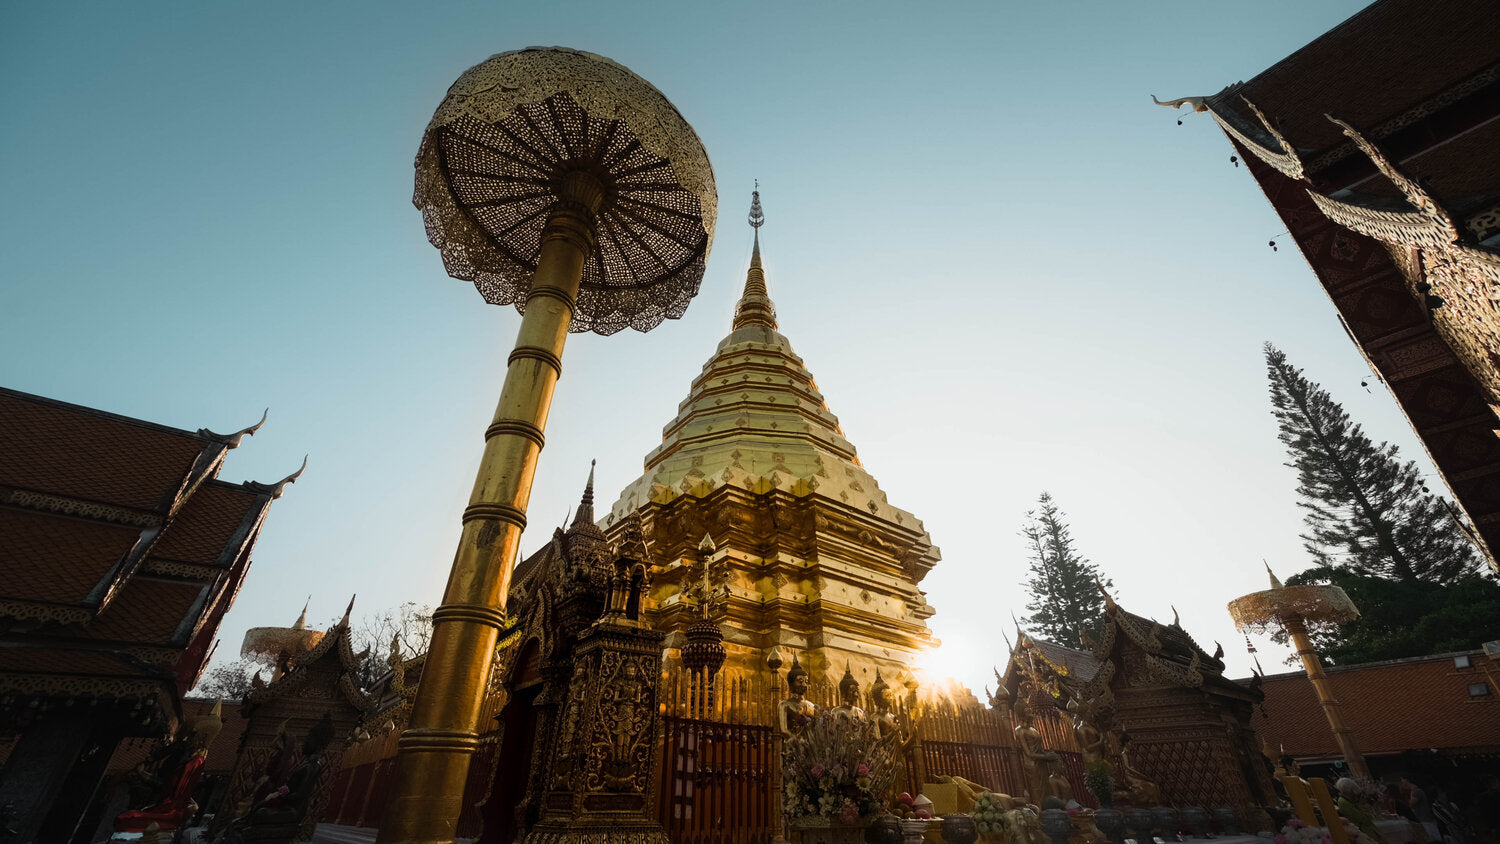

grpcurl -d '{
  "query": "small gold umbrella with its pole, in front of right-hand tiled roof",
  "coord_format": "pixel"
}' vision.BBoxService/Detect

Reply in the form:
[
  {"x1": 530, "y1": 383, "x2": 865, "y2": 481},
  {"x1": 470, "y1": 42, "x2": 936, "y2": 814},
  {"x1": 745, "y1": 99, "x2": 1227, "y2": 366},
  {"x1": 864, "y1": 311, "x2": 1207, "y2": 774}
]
[{"x1": 1229, "y1": 565, "x2": 1370, "y2": 777}]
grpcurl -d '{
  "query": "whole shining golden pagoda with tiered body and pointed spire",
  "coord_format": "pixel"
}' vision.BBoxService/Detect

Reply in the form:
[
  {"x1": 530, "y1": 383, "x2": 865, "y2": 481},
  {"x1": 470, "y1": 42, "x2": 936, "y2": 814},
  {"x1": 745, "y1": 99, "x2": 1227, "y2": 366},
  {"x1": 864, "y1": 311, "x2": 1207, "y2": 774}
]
[{"x1": 603, "y1": 190, "x2": 939, "y2": 688}]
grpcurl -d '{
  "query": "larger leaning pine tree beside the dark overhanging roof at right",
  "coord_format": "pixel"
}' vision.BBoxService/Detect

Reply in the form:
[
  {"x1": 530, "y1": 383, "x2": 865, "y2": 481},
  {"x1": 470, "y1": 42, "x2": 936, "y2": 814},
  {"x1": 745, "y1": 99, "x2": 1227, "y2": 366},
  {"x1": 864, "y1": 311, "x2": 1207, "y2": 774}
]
[{"x1": 1266, "y1": 343, "x2": 1481, "y2": 583}]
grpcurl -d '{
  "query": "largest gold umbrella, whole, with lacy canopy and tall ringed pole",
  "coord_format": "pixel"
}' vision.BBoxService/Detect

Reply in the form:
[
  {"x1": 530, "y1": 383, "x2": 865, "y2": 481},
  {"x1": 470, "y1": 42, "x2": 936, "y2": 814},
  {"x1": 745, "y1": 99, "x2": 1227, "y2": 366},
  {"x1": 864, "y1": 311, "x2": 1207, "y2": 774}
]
[{"x1": 380, "y1": 48, "x2": 719, "y2": 843}]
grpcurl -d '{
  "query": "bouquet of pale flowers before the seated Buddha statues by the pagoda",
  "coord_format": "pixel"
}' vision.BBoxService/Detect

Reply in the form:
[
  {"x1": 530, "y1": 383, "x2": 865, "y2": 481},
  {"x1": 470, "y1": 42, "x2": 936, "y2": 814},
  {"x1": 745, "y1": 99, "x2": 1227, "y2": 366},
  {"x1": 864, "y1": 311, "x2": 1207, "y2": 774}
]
[{"x1": 782, "y1": 712, "x2": 896, "y2": 823}]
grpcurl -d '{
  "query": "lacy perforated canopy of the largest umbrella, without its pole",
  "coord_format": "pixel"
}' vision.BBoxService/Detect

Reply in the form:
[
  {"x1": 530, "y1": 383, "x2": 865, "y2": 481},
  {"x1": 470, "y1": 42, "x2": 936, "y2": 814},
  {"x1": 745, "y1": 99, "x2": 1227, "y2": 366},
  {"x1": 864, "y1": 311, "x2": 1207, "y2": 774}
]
[{"x1": 413, "y1": 46, "x2": 719, "y2": 334}]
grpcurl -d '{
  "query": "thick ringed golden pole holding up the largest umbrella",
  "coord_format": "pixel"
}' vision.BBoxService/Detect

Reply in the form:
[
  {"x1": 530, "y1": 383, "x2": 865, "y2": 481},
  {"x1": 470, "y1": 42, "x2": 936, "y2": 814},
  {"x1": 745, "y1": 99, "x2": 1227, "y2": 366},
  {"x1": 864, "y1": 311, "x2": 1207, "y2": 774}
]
[{"x1": 378, "y1": 171, "x2": 603, "y2": 844}]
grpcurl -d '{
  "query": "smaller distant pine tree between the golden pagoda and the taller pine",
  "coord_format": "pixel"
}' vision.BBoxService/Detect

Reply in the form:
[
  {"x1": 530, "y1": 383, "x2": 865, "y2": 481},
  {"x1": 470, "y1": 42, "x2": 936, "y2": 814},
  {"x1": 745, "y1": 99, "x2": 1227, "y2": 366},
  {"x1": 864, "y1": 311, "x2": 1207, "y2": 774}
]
[{"x1": 1022, "y1": 492, "x2": 1113, "y2": 648}]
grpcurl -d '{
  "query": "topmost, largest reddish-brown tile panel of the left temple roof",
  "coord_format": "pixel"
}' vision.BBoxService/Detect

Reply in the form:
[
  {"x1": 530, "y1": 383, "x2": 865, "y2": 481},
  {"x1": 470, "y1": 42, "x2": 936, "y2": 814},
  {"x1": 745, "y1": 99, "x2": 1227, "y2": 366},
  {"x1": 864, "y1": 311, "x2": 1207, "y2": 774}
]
[{"x1": 0, "y1": 390, "x2": 213, "y2": 510}]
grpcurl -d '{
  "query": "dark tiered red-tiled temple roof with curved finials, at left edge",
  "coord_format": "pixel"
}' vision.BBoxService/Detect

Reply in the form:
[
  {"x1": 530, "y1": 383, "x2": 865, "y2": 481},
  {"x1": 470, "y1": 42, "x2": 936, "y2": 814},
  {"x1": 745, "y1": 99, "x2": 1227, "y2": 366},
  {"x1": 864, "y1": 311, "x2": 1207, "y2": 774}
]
[{"x1": 0, "y1": 388, "x2": 293, "y2": 734}]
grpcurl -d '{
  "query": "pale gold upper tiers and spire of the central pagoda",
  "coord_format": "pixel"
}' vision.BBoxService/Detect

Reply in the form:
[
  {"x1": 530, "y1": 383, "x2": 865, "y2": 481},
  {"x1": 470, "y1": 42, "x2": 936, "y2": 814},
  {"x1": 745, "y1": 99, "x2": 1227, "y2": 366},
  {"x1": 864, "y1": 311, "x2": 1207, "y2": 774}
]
[{"x1": 605, "y1": 195, "x2": 939, "y2": 578}]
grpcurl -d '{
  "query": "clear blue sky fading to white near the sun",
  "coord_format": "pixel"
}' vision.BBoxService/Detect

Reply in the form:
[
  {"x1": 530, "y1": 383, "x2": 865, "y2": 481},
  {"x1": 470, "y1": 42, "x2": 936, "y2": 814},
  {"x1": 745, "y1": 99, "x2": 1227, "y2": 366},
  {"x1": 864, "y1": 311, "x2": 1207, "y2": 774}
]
[{"x1": 0, "y1": 0, "x2": 1419, "y2": 692}]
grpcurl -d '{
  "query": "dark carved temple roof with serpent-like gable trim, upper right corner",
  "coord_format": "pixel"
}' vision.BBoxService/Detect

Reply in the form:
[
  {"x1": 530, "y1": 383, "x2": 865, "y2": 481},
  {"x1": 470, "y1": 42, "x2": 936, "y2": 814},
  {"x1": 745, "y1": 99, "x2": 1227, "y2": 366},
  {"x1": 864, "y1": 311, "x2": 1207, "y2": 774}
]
[{"x1": 1175, "y1": 0, "x2": 1500, "y2": 565}]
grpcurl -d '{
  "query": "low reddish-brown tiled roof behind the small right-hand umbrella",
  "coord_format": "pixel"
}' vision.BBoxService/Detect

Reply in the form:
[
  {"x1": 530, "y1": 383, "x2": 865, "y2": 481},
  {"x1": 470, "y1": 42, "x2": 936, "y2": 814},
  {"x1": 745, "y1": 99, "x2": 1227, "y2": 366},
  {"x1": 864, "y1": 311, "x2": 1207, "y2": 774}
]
[{"x1": 1254, "y1": 652, "x2": 1500, "y2": 759}]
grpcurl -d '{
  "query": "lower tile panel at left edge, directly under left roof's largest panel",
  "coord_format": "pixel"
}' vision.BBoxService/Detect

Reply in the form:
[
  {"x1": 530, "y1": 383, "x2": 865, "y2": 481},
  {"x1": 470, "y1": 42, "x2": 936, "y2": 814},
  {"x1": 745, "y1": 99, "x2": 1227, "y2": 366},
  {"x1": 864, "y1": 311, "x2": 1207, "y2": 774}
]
[{"x1": 0, "y1": 512, "x2": 141, "y2": 604}]
